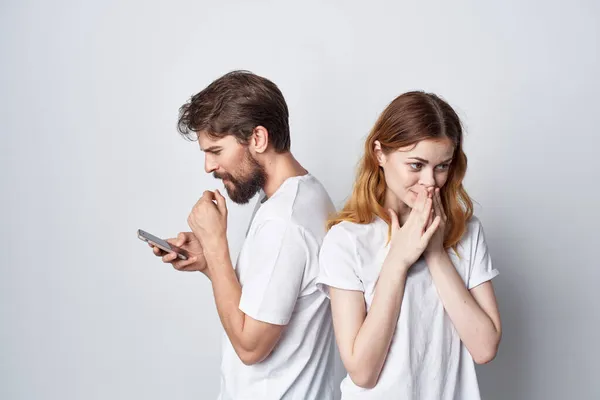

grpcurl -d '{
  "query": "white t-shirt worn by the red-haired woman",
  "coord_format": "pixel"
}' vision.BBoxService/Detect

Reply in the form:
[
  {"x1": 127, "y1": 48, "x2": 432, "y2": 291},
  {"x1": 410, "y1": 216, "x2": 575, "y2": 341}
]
[{"x1": 317, "y1": 217, "x2": 498, "y2": 400}]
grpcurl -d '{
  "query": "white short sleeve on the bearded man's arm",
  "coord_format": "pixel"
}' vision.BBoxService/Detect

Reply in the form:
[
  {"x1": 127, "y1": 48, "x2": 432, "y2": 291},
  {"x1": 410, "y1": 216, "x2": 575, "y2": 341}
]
[{"x1": 239, "y1": 220, "x2": 307, "y2": 325}]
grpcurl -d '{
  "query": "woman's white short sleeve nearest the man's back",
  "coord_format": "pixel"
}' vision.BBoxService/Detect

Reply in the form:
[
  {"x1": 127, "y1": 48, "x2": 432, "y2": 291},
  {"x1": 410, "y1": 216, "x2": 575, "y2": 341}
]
[{"x1": 316, "y1": 225, "x2": 365, "y2": 296}]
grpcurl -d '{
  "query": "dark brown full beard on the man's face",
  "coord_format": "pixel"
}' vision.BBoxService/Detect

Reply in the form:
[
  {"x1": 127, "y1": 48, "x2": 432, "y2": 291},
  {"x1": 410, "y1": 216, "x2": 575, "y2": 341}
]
[{"x1": 213, "y1": 151, "x2": 267, "y2": 204}]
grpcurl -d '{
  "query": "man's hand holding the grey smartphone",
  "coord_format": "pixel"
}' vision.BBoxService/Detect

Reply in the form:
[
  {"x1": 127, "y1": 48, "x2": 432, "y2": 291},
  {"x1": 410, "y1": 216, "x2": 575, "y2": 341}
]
[{"x1": 150, "y1": 232, "x2": 207, "y2": 273}]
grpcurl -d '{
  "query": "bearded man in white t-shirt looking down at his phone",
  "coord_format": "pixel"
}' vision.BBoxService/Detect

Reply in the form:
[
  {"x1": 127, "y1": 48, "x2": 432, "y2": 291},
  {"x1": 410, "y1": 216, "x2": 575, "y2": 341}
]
[{"x1": 154, "y1": 71, "x2": 335, "y2": 400}]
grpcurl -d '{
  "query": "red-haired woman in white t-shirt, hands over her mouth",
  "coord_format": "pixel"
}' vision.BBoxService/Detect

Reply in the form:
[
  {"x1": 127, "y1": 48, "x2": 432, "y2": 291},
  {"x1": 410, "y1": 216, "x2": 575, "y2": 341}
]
[{"x1": 317, "y1": 92, "x2": 501, "y2": 400}]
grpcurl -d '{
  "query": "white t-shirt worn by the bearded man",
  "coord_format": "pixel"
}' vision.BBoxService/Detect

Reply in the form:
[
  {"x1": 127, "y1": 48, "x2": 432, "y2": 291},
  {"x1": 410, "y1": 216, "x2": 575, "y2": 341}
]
[{"x1": 219, "y1": 174, "x2": 335, "y2": 400}]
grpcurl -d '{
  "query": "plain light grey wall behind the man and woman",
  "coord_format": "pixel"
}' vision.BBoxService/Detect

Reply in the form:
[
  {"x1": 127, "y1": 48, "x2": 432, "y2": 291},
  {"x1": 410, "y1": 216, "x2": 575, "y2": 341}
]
[{"x1": 0, "y1": 0, "x2": 600, "y2": 400}]
